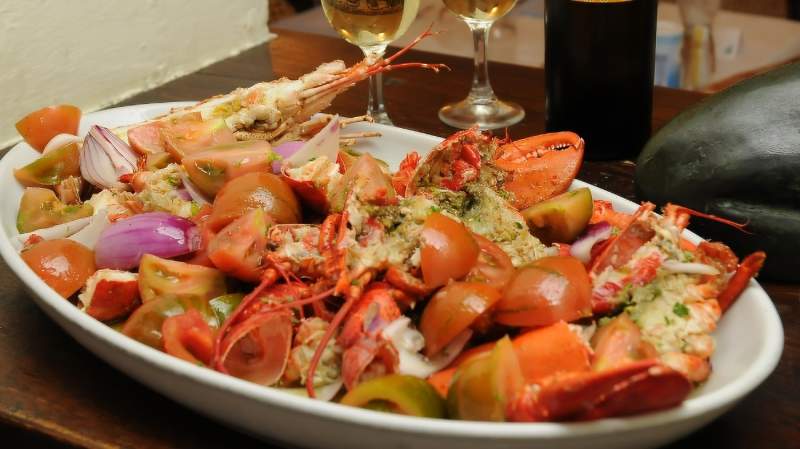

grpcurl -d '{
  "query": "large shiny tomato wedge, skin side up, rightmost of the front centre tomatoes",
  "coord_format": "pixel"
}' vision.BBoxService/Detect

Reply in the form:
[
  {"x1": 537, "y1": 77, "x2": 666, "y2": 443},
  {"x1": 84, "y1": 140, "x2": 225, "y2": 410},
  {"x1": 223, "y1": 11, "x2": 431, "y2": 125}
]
[{"x1": 495, "y1": 256, "x2": 592, "y2": 327}]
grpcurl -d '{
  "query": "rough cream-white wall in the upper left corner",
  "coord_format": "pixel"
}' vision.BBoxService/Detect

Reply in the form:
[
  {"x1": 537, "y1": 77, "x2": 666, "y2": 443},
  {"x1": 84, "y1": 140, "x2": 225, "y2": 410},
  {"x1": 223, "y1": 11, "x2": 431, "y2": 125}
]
[{"x1": 0, "y1": 0, "x2": 269, "y2": 148}]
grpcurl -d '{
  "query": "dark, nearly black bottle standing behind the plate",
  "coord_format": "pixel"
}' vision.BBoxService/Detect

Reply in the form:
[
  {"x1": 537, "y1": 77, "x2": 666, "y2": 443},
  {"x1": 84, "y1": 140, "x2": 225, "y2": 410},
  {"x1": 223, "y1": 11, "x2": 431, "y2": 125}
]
[{"x1": 545, "y1": 0, "x2": 658, "y2": 160}]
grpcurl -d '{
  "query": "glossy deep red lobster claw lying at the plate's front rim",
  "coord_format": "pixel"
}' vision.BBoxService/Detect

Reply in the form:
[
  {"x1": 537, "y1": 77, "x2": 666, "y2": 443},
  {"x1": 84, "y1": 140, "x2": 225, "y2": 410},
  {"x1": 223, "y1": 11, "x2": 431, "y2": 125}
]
[{"x1": 506, "y1": 359, "x2": 692, "y2": 422}]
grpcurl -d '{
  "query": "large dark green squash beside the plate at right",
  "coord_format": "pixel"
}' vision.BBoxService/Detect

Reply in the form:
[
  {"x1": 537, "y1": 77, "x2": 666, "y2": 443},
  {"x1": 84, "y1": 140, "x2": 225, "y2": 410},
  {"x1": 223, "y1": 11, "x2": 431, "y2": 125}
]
[{"x1": 636, "y1": 63, "x2": 800, "y2": 281}]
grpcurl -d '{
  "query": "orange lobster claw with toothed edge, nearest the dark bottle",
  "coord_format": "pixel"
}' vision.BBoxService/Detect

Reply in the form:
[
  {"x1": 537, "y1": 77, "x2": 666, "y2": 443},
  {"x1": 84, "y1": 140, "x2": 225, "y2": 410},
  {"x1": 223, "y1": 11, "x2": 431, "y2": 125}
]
[{"x1": 494, "y1": 131, "x2": 584, "y2": 210}]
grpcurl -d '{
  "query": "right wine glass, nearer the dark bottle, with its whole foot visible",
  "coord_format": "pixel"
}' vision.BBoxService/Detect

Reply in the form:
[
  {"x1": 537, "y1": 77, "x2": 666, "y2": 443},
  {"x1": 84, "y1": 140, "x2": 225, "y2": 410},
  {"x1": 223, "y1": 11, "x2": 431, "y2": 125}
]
[{"x1": 439, "y1": 0, "x2": 525, "y2": 129}]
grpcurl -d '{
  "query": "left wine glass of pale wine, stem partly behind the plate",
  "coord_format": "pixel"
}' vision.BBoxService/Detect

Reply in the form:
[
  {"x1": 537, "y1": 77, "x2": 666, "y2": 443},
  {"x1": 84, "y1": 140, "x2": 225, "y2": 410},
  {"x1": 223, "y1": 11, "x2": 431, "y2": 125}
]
[{"x1": 321, "y1": 0, "x2": 420, "y2": 125}]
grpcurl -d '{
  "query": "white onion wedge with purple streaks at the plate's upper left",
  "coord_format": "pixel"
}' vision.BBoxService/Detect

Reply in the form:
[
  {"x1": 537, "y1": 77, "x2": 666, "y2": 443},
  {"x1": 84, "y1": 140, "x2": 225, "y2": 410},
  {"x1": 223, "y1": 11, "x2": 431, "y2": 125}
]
[{"x1": 80, "y1": 125, "x2": 138, "y2": 189}]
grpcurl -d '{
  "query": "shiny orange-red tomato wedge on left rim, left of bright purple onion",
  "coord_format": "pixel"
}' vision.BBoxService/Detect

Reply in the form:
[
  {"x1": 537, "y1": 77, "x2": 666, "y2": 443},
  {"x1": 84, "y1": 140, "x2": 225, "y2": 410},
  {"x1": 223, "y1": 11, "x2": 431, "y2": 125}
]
[{"x1": 20, "y1": 239, "x2": 97, "y2": 298}]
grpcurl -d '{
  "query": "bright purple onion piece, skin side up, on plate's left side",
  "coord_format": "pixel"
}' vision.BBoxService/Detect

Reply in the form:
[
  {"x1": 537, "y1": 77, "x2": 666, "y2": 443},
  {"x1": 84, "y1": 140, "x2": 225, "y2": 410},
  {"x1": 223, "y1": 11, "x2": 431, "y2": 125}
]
[{"x1": 94, "y1": 212, "x2": 201, "y2": 270}]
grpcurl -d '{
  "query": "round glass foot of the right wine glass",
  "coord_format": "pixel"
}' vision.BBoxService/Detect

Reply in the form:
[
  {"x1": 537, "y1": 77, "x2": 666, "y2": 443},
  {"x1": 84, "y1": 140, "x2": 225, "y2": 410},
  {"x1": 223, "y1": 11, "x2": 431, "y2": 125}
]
[{"x1": 439, "y1": 98, "x2": 525, "y2": 129}]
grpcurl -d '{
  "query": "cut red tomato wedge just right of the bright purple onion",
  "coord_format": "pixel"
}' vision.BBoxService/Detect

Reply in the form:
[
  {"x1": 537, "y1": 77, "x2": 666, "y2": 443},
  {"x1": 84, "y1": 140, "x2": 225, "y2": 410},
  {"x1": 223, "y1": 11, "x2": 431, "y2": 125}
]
[{"x1": 207, "y1": 208, "x2": 272, "y2": 282}]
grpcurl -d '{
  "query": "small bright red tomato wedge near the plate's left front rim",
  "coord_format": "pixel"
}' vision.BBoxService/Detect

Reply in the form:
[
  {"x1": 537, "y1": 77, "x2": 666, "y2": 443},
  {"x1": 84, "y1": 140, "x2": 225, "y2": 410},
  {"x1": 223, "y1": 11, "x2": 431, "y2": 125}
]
[{"x1": 161, "y1": 309, "x2": 214, "y2": 365}]
